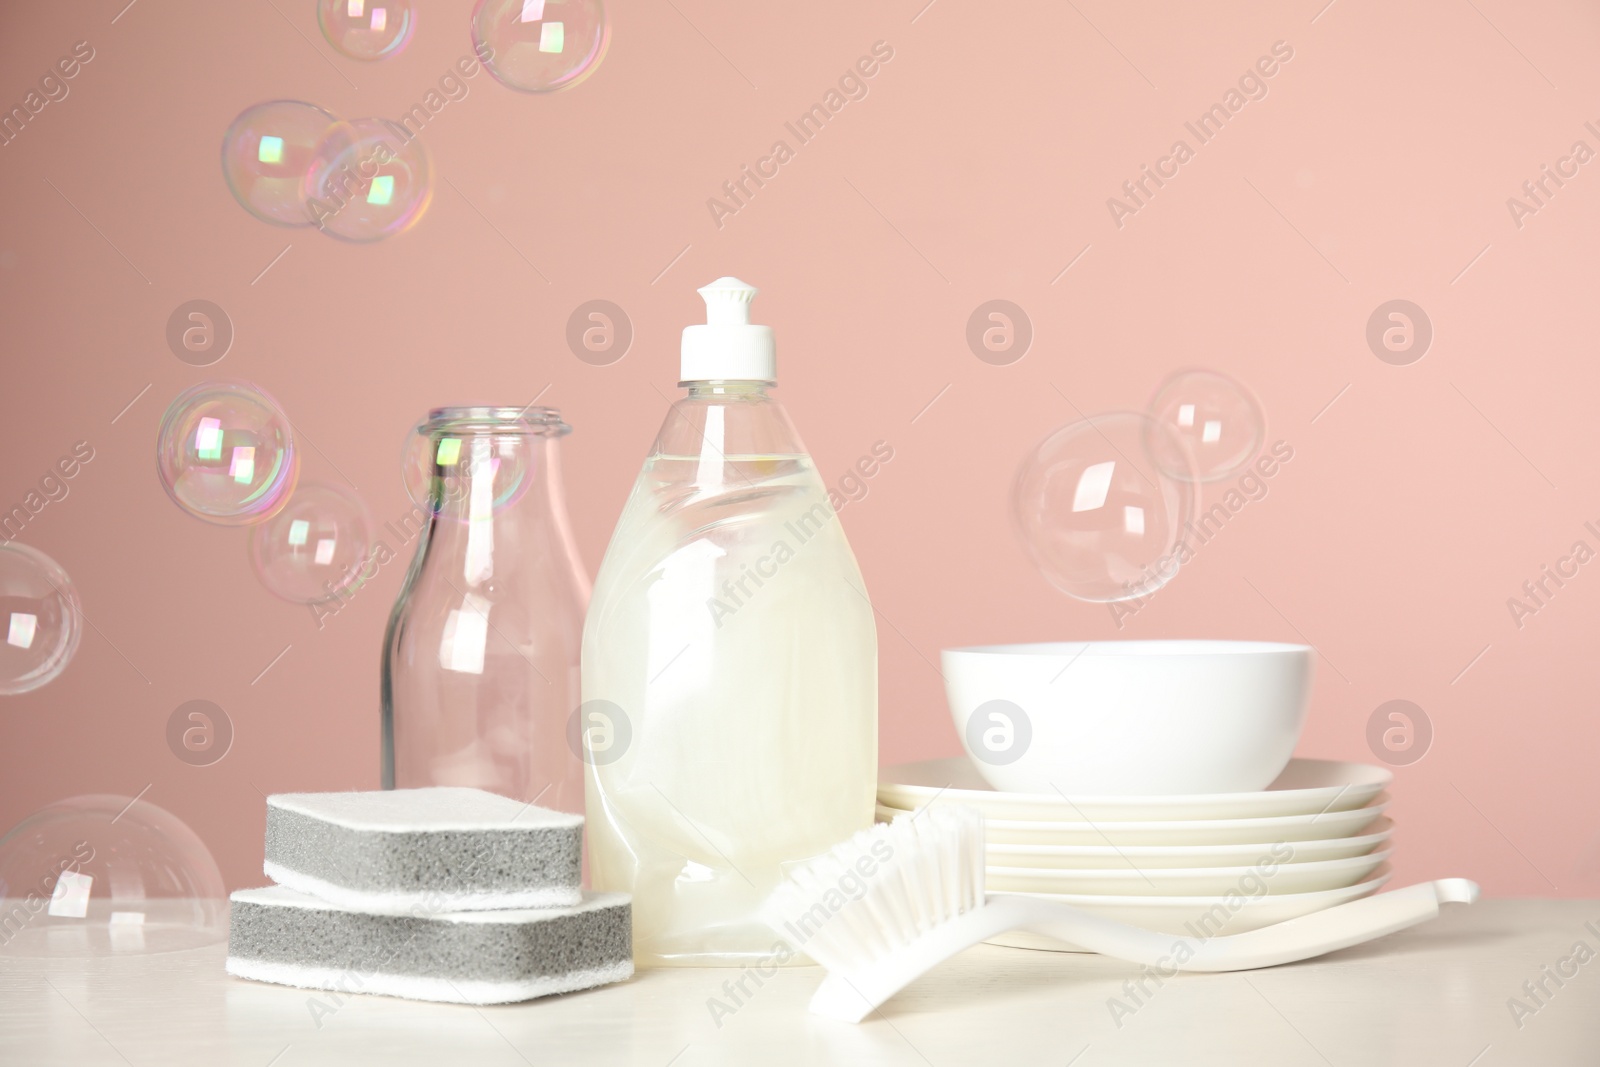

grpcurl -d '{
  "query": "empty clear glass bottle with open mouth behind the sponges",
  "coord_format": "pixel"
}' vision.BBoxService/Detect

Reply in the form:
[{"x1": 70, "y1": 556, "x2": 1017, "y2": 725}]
[{"x1": 382, "y1": 408, "x2": 589, "y2": 811}]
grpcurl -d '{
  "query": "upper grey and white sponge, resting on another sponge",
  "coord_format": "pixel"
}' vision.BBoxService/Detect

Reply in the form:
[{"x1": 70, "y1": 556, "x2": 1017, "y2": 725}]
[{"x1": 262, "y1": 785, "x2": 584, "y2": 915}]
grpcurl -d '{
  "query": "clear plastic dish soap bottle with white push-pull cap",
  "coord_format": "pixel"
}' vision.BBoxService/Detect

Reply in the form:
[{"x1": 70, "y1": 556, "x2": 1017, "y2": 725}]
[{"x1": 574, "y1": 278, "x2": 877, "y2": 966}]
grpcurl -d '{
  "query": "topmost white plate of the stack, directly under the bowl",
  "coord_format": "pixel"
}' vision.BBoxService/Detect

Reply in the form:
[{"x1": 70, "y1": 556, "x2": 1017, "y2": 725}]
[{"x1": 878, "y1": 757, "x2": 1394, "y2": 822}]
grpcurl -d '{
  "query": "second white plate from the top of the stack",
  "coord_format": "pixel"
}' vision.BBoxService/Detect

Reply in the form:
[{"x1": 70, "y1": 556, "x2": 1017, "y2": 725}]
[{"x1": 877, "y1": 795, "x2": 1389, "y2": 848}]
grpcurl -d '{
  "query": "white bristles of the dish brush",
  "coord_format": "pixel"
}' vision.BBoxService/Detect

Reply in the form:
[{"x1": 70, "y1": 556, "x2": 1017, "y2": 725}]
[{"x1": 762, "y1": 806, "x2": 984, "y2": 971}]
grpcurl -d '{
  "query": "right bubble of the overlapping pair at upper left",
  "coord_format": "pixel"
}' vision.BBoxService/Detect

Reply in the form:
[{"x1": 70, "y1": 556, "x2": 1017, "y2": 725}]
[{"x1": 306, "y1": 118, "x2": 434, "y2": 242}]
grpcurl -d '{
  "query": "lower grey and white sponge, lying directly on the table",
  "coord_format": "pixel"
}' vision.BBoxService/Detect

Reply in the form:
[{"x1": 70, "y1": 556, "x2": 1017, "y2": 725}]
[{"x1": 227, "y1": 886, "x2": 634, "y2": 1005}]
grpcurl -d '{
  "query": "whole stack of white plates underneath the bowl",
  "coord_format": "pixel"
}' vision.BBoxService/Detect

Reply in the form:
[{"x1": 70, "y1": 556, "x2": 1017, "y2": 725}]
[{"x1": 878, "y1": 757, "x2": 1394, "y2": 949}]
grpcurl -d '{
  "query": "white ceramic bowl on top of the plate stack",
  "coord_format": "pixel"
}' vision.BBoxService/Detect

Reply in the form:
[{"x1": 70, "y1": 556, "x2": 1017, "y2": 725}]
[{"x1": 942, "y1": 641, "x2": 1312, "y2": 797}]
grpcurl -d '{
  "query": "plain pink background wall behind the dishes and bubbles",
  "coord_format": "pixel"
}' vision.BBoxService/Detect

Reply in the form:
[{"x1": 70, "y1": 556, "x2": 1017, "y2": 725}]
[{"x1": 0, "y1": 0, "x2": 1600, "y2": 896}]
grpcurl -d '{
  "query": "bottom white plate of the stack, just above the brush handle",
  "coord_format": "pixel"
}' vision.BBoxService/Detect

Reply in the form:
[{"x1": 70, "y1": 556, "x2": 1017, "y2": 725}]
[{"x1": 989, "y1": 865, "x2": 1392, "y2": 952}]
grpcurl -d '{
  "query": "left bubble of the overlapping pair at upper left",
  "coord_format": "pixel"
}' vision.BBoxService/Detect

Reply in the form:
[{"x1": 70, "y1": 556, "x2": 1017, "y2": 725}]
[{"x1": 222, "y1": 101, "x2": 338, "y2": 226}]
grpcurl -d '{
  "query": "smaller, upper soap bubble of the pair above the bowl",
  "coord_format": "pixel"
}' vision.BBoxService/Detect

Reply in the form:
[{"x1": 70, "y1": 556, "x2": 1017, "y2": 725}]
[{"x1": 1150, "y1": 371, "x2": 1267, "y2": 482}]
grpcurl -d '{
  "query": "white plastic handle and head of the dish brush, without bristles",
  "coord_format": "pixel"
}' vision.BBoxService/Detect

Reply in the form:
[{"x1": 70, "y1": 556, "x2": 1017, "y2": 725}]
[{"x1": 811, "y1": 878, "x2": 1478, "y2": 1022}]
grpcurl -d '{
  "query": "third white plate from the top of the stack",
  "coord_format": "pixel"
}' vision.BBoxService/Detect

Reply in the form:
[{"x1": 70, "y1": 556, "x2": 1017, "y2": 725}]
[{"x1": 986, "y1": 819, "x2": 1395, "y2": 870}]
